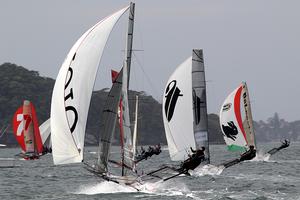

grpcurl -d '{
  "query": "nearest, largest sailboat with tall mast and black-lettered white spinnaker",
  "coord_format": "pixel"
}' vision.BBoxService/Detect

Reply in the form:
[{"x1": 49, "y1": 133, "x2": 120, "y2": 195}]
[{"x1": 50, "y1": 3, "x2": 141, "y2": 188}]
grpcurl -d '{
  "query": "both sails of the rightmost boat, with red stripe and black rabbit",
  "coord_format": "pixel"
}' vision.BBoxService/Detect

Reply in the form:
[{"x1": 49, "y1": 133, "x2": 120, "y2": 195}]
[{"x1": 220, "y1": 83, "x2": 256, "y2": 151}]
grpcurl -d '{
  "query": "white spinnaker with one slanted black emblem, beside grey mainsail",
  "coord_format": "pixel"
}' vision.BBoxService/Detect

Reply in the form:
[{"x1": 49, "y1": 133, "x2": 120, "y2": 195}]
[{"x1": 162, "y1": 57, "x2": 196, "y2": 161}]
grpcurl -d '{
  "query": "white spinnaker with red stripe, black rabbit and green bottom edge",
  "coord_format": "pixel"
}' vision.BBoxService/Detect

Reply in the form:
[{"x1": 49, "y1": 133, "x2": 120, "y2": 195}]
[{"x1": 220, "y1": 83, "x2": 247, "y2": 150}]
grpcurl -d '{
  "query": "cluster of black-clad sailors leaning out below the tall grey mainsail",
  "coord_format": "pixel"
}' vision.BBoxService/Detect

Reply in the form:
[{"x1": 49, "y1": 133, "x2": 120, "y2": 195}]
[{"x1": 178, "y1": 147, "x2": 205, "y2": 172}]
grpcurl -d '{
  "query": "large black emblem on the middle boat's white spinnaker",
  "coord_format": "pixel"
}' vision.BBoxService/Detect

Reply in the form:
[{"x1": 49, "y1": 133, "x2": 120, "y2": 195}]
[{"x1": 165, "y1": 80, "x2": 183, "y2": 122}]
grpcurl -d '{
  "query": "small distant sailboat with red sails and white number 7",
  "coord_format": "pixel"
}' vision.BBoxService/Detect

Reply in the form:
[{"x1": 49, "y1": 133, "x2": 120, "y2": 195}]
[{"x1": 13, "y1": 100, "x2": 45, "y2": 160}]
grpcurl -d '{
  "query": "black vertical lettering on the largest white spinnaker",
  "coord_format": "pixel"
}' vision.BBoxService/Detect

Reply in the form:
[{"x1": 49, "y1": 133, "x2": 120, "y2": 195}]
[{"x1": 65, "y1": 53, "x2": 78, "y2": 133}]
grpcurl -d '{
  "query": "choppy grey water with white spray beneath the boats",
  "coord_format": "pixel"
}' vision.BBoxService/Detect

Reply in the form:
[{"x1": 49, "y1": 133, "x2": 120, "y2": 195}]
[{"x1": 0, "y1": 143, "x2": 300, "y2": 200}]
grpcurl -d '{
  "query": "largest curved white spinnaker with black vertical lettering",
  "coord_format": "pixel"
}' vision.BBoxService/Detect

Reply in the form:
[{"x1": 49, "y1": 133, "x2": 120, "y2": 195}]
[{"x1": 50, "y1": 7, "x2": 128, "y2": 164}]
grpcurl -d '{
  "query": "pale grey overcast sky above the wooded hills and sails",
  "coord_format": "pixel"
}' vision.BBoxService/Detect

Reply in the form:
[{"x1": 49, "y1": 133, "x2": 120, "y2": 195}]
[{"x1": 0, "y1": 0, "x2": 300, "y2": 121}]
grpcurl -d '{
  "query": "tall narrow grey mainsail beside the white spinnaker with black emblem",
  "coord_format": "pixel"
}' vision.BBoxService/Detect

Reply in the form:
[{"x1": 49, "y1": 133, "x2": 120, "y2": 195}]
[{"x1": 192, "y1": 49, "x2": 209, "y2": 163}]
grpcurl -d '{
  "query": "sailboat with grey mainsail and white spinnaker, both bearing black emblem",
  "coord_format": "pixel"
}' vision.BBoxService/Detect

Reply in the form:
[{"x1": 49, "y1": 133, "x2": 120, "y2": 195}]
[{"x1": 149, "y1": 49, "x2": 210, "y2": 180}]
